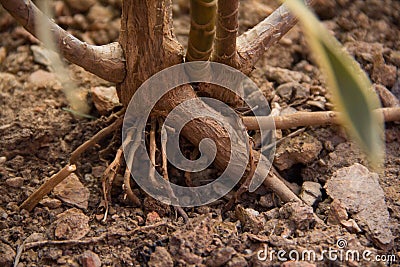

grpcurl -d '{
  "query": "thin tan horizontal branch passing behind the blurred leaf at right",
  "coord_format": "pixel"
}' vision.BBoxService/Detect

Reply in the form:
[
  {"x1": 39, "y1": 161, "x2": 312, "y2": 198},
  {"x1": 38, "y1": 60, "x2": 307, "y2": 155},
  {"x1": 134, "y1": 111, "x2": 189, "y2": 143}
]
[{"x1": 243, "y1": 107, "x2": 400, "y2": 130}]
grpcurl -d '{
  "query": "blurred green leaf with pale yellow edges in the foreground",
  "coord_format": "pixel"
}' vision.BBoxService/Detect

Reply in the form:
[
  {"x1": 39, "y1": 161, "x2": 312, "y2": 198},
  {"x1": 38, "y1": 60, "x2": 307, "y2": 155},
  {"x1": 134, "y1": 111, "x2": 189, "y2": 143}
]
[{"x1": 285, "y1": 0, "x2": 384, "y2": 167}]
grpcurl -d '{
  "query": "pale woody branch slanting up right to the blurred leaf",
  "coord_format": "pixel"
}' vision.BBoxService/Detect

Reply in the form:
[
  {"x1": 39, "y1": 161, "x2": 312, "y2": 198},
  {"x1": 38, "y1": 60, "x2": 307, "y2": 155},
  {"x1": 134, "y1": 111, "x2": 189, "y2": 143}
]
[{"x1": 237, "y1": 0, "x2": 315, "y2": 74}]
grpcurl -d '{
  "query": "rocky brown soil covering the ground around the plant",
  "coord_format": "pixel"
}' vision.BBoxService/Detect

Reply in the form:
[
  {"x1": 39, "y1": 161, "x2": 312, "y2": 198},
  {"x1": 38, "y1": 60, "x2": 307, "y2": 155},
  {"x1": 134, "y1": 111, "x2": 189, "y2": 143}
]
[{"x1": 0, "y1": 0, "x2": 400, "y2": 267}]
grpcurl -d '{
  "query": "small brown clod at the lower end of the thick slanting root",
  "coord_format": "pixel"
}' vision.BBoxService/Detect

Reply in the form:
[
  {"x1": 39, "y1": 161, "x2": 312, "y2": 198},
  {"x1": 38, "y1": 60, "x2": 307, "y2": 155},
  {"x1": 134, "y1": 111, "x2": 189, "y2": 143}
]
[{"x1": 279, "y1": 202, "x2": 316, "y2": 230}]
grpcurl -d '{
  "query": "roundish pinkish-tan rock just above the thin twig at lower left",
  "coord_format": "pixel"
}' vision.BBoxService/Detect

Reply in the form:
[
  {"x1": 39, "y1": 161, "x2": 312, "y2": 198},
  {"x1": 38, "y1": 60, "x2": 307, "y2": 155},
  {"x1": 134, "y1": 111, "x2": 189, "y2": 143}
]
[{"x1": 54, "y1": 208, "x2": 90, "y2": 239}]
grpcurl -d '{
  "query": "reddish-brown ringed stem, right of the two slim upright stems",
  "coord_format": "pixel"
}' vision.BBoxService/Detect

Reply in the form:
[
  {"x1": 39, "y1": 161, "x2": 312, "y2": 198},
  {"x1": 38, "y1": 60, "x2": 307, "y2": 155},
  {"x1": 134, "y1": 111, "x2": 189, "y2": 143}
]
[{"x1": 213, "y1": 0, "x2": 239, "y2": 68}]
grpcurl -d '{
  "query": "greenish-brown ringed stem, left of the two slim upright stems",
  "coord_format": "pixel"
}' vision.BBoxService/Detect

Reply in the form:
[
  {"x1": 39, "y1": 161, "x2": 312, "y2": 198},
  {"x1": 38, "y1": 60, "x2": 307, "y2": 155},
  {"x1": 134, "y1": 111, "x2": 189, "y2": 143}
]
[{"x1": 186, "y1": 0, "x2": 217, "y2": 61}]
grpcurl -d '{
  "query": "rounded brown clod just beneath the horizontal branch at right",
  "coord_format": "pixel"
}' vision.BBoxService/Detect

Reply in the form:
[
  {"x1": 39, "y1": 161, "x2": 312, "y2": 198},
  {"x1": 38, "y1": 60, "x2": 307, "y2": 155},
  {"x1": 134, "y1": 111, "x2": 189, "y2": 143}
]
[{"x1": 274, "y1": 133, "x2": 322, "y2": 171}]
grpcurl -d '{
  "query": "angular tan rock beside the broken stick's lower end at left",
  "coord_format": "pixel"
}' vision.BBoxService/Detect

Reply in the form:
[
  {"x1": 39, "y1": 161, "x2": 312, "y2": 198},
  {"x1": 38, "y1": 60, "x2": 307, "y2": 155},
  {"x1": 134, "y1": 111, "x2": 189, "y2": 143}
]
[{"x1": 53, "y1": 173, "x2": 90, "y2": 209}]
